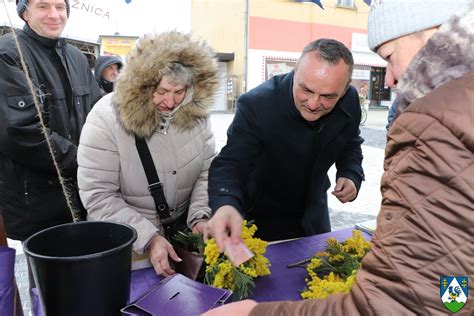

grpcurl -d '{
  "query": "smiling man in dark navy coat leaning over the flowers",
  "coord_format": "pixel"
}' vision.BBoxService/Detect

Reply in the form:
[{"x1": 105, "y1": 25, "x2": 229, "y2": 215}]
[{"x1": 209, "y1": 39, "x2": 364, "y2": 250}]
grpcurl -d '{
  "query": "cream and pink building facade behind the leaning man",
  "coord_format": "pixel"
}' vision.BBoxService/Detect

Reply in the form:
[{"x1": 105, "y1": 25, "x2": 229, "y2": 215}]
[{"x1": 191, "y1": 0, "x2": 395, "y2": 110}]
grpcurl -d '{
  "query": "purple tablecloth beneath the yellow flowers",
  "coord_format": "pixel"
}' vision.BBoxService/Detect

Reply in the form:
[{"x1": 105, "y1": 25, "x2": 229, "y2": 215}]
[{"x1": 35, "y1": 228, "x2": 371, "y2": 316}]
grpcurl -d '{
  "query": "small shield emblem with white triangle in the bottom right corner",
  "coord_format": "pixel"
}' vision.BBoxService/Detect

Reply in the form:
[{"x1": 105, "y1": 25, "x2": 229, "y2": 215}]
[{"x1": 439, "y1": 275, "x2": 469, "y2": 313}]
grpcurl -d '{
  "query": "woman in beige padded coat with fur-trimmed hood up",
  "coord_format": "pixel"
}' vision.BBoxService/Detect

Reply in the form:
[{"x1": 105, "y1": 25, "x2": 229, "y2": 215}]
[{"x1": 78, "y1": 31, "x2": 218, "y2": 275}]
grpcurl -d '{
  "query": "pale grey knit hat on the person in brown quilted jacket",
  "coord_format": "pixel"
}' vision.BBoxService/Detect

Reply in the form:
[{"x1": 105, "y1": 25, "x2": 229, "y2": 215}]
[{"x1": 368, "y1": 0, "x2": 474, "y2": 52}]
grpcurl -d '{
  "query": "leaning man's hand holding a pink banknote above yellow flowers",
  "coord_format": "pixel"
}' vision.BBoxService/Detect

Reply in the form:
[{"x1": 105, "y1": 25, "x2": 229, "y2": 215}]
[{"x1": 207, "y1": 205, "x2": 243, "y2": 252}]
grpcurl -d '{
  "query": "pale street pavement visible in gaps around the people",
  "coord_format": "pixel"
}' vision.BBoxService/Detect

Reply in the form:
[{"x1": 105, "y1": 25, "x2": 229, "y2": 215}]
[{"x1": 8, "y1": 110, "x2": 388, "y2": 315}]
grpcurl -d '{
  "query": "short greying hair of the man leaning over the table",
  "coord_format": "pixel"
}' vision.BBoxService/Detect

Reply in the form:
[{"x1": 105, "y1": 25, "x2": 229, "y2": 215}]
[{"x1": 300, "y1": 38, "x2": 354, "y2": 76}]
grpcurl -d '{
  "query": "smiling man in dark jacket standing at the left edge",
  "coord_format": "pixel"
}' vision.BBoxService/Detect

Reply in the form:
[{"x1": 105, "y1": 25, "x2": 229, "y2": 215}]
[{"x1": 0, "y1": 0, "x2": 100, "y2": 240}]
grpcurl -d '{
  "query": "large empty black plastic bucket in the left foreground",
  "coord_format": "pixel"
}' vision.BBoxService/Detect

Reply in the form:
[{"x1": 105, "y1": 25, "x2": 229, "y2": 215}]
[{"x1": 23, "y1": 222, "x2": 137, "y2": 316}]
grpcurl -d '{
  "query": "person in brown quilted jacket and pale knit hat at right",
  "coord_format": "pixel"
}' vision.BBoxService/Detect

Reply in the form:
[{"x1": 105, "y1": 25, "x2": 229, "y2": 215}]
[{"x1": 205, "y1": 0, "x2": 474, "y2": 316}]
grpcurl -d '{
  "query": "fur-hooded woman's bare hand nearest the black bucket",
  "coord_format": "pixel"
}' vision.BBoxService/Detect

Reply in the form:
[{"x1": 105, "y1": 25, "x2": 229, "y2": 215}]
[{"x1": 148, "y1": 234, "x2": 182, "y2": 277}]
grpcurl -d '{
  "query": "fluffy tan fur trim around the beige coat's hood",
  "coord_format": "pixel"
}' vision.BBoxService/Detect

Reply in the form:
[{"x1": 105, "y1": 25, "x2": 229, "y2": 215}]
[{"x1": 114, "y1": 31, "x2": 219, "y2": 138}]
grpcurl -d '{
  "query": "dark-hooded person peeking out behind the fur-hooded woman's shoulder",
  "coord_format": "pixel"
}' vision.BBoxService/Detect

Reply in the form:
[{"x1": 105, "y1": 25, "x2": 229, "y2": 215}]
[{"x1": 94, "y1": 55, "x2": 123, "y2": 95}]
